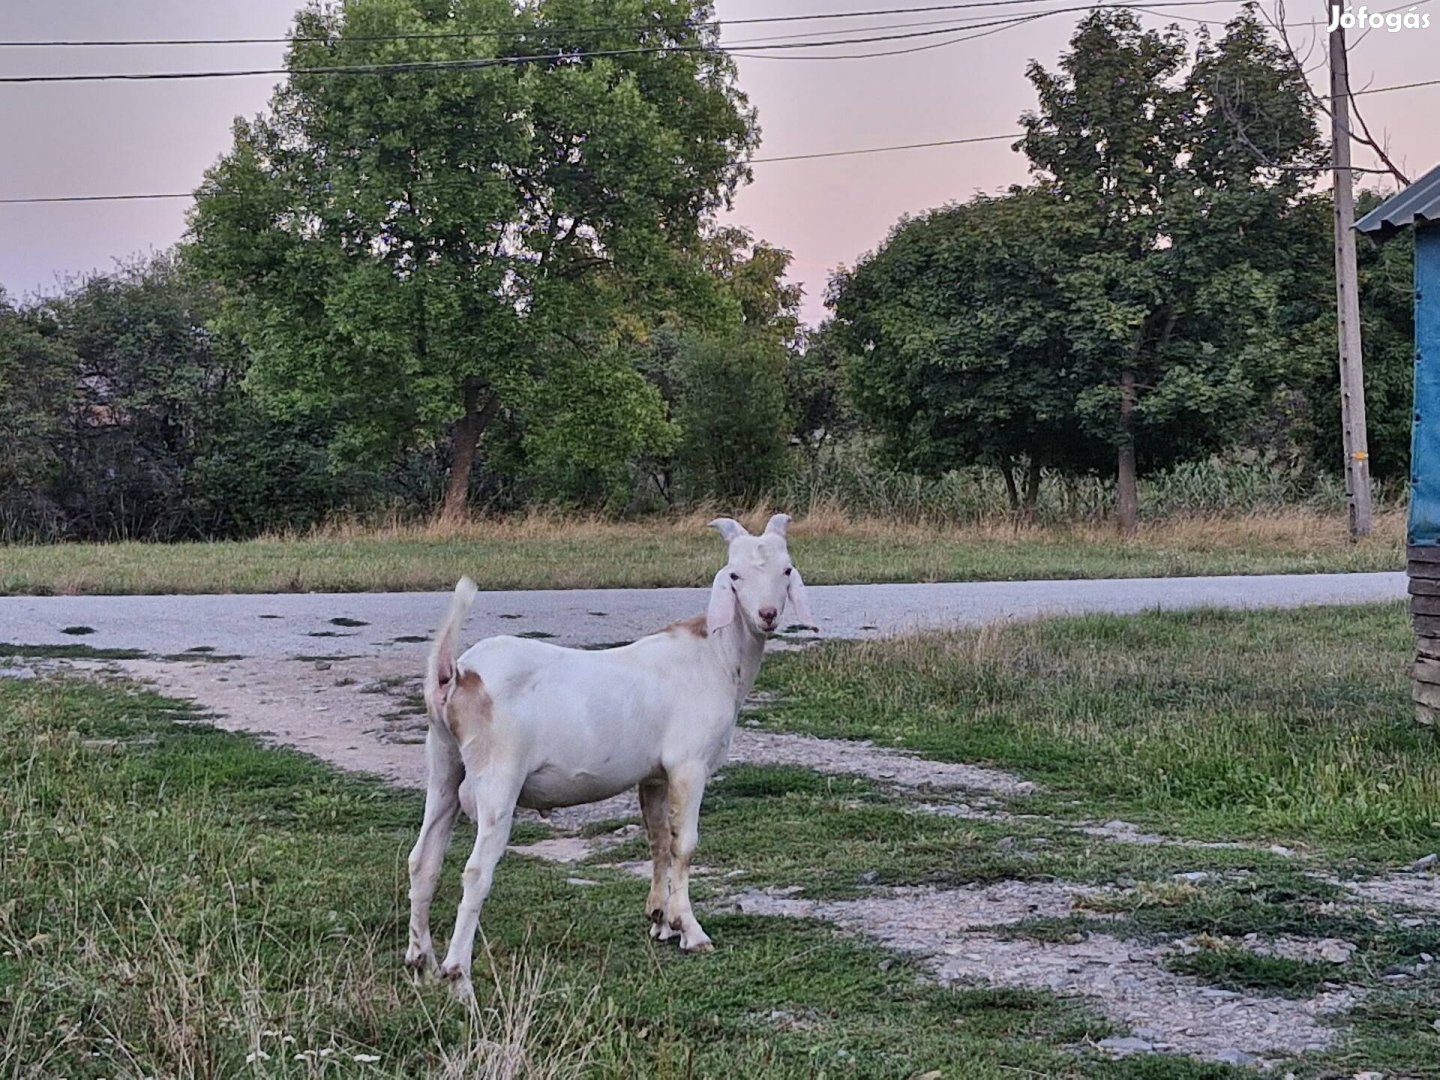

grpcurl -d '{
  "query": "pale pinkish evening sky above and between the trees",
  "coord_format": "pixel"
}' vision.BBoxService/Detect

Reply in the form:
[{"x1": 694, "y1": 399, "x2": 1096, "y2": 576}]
[{"x1": 0, "y1": 0, "x2": 1440, "y2": 321}]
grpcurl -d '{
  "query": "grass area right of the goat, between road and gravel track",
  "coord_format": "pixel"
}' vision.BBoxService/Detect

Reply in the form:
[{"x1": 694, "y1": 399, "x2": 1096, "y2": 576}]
[{"x1": 757, "y1": 603, "x2": 1440, "y2": 864}]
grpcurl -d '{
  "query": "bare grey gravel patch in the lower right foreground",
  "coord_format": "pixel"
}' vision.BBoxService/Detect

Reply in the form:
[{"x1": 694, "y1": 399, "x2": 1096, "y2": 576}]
[{"x1": 729, "y1": 881, "x2": 1356, "y2": 1064}]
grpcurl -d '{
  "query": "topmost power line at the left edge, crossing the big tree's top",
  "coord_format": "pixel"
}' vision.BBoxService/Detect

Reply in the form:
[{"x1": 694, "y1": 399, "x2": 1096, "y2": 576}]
[{"x1": 0, "y1": 0, "x2": 1234, "y2": 49}]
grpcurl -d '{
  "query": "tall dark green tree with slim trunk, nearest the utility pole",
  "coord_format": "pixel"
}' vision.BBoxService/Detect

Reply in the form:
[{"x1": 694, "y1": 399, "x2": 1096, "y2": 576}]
[{"x1": 1020, "y1": 6, "x2": 1320, "y2": 533}]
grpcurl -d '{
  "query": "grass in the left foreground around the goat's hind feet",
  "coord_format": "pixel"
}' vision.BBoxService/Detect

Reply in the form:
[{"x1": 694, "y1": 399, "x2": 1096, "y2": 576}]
[{"x1": 0, "y1": 681, "x2": 1233, "y2": 1080}]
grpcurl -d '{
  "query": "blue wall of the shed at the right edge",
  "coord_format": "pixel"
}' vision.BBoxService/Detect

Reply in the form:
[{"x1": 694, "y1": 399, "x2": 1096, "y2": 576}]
[{"x1": 1410, "y1": 223, "x2": 1440, "y2": 546}]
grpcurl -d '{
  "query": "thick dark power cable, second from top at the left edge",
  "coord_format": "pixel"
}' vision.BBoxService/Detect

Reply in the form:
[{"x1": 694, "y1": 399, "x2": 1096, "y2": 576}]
[{"x1": 0, "y1": 0, "x2": 1233, "y2": 84}]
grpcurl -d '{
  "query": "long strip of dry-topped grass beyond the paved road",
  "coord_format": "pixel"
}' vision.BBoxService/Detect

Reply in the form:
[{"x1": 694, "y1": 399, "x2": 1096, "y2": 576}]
[{"x1": 0, "y1": 511, "x2": 1404, "y2": 595}]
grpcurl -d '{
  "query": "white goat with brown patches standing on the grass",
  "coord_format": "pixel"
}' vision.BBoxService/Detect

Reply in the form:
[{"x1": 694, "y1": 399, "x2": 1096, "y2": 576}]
[{"x1": 405, "y1": 514, "x2": 819, "y2": 995}]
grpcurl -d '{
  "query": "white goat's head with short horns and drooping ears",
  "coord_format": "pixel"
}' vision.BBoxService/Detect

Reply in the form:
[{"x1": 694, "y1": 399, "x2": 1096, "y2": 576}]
[{"x1": 706, "y1": 514, "x2": 819, "y2": 634}]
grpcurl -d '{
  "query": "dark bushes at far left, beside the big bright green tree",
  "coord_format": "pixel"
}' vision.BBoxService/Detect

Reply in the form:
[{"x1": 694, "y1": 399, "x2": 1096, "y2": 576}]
[{"x1": 0, "y1": 256, "x2": 239, "y2": 537}]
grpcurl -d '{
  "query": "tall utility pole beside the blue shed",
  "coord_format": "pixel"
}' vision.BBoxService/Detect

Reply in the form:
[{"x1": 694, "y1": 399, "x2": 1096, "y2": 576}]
[{"x1": 1326, "y1": 16, "x2": 1372, "y2": 540}]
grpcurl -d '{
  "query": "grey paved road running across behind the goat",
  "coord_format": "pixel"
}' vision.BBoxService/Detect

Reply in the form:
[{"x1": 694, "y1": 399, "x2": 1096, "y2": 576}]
[{"x1": 0, "y1": 573, "x2": 1405, "y2": 657}]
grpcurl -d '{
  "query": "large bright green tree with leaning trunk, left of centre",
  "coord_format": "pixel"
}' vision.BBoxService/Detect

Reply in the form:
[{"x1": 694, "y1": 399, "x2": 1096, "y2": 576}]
[{"x1": 192, "y1": 0, "x2": 757, "y2": 516}]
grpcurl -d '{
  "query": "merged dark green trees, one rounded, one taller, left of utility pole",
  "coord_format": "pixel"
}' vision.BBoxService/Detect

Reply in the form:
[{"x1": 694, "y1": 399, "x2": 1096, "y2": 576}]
[{"x1": 829, "y1": 9, "x2": 1319, "y2": 527}]
